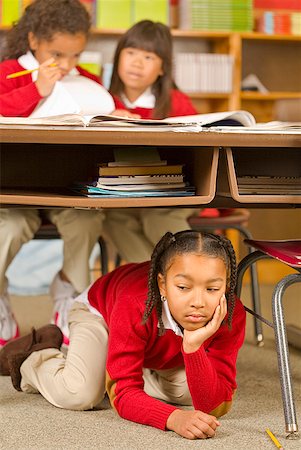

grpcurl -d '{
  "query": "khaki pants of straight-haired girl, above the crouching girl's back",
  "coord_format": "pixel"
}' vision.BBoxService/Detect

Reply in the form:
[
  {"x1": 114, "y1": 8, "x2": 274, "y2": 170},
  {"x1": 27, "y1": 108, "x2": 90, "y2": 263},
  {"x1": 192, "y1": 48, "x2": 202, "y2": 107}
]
[{"x1": 104, "y1": 208, "x2": 199, "y2": 262}]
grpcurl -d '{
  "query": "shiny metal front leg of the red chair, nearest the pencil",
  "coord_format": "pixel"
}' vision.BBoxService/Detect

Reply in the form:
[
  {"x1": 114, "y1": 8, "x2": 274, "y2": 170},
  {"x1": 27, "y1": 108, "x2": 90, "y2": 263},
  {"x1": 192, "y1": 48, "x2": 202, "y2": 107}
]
[{"x1": 272, "y1": 273, "x2": 301, "y2": 439}]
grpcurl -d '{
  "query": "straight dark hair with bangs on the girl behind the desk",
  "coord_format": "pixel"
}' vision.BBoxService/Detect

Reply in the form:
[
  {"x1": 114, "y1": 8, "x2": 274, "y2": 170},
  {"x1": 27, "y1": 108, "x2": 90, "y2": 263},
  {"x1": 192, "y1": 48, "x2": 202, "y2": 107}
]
[{"x1": 109, "y1": 20, "x2": 175, "y2": 119}]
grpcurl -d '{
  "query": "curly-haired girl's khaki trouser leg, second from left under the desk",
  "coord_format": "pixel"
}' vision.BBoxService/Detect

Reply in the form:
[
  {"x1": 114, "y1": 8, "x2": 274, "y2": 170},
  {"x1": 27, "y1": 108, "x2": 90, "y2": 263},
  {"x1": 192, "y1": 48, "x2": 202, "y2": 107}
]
[{"x1": 47, "y1": 208, "x2": 104, "y2": 293}]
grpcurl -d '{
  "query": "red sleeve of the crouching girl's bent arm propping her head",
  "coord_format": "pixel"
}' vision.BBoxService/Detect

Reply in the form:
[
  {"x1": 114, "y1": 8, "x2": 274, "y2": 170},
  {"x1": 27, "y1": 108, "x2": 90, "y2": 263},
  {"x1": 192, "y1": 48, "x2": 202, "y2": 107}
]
[{"x1": 183, "y1": 300, "x2": 246, "y2": 416}]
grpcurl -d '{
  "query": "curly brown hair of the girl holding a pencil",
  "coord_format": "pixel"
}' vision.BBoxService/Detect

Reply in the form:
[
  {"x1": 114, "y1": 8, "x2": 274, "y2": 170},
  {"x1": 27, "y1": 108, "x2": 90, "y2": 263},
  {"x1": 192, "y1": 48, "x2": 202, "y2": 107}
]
[{"x1": 1, "y1": 0, "x2": 91, "y2": 60}]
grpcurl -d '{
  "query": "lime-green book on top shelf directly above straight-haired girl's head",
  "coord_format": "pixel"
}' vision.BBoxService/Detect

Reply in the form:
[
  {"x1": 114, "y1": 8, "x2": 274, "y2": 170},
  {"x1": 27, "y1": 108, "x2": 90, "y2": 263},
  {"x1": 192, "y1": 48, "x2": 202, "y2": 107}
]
[{"x1": 133, "y1": 0, "x2": 169, "y2": 25}]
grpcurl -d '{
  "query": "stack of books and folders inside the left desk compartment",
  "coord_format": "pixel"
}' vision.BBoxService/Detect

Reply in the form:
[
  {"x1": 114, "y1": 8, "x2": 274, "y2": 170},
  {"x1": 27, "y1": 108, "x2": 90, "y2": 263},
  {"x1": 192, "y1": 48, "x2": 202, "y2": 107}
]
[{"x1": 74, "y1": 148, "x2": 195, "y2": 198}]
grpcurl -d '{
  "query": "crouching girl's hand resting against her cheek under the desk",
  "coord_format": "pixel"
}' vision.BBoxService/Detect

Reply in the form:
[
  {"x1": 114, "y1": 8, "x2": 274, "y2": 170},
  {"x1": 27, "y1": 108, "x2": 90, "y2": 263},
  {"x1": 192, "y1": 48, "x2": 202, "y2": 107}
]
[{"x1": 183, "y1": 294, "x2": 227, "y2": 353}]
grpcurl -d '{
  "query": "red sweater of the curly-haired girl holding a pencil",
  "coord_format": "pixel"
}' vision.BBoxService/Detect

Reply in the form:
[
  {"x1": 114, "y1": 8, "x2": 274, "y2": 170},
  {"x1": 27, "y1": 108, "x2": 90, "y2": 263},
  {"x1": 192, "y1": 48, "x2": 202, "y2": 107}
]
[{"x1": 0, "y1": 59, "x2": 101, "y2": 117}]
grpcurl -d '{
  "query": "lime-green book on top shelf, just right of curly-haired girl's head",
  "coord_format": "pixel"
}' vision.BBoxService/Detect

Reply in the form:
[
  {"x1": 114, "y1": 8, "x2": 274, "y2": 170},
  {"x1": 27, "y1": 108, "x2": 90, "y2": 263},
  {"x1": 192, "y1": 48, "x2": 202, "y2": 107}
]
[{"x1": 96, "y1": 0, "x2": 132, "y2": 29}]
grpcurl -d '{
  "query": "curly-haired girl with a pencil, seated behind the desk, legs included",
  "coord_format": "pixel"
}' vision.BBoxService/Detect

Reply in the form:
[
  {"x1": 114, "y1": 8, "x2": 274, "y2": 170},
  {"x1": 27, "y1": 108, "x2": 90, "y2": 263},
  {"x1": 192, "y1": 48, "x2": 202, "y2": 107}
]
[{"x1": 0, "y1": 0, "x2": 132, "y2": 346}]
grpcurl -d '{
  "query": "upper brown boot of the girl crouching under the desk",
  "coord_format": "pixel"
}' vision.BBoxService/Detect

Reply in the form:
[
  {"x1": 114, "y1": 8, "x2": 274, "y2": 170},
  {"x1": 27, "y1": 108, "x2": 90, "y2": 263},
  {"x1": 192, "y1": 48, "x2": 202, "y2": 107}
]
[{"x1": 0, "y1": 324, "x2": 63, "y2": 375}]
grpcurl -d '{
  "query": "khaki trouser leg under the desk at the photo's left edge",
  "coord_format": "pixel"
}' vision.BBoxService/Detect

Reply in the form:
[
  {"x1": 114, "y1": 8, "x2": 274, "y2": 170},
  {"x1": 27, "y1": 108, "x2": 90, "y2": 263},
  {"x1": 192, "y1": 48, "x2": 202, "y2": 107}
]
[{"x1": 0, "y1": 208, "x2": 41, "y2": 295}]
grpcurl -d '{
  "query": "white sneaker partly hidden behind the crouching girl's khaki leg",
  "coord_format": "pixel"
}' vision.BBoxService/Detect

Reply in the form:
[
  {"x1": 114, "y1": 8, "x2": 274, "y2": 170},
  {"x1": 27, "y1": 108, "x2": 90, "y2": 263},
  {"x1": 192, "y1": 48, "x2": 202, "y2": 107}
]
[{"x1": 50, "y1": 274, "x2": 78, "y2": 345}]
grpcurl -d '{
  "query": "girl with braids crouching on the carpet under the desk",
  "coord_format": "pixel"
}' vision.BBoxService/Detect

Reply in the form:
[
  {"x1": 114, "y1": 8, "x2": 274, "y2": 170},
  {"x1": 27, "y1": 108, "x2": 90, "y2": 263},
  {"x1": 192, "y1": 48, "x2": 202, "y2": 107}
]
[{"x1": 0, "y1": 230, "x2": 246, "y2": 442}]
